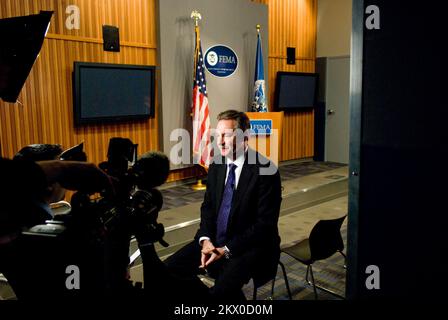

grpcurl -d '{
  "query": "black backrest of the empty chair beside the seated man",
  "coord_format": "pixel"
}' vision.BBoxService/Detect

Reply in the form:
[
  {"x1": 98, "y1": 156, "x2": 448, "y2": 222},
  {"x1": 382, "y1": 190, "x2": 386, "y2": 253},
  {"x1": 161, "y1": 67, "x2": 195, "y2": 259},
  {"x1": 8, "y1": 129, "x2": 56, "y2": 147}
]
[{"x1": 309, "y1": 215, "x2": 346, "y2": 261}]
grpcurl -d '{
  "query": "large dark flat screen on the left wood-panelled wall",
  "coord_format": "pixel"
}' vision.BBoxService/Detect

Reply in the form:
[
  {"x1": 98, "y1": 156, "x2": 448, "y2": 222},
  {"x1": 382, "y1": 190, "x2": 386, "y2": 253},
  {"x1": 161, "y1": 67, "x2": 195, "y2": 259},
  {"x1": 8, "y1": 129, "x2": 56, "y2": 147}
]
[{"x1": 73, "y1": 61, "x2": 155, "y2": 125}]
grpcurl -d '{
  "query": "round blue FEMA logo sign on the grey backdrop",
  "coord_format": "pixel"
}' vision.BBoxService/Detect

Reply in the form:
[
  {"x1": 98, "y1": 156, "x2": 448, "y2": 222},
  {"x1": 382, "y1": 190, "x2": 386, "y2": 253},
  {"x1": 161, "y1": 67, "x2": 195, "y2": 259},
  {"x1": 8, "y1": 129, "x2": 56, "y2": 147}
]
[{"x1": 205, "y1": 45, "x2": 238, "y2": 78}]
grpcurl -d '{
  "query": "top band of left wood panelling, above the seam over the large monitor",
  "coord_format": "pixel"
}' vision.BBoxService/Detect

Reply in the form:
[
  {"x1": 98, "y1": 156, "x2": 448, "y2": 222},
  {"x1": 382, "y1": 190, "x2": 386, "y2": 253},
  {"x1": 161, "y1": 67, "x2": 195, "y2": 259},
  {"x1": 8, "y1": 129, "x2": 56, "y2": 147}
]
[{"x1": 0, "y1": 0, "x2": 157, "y2": 48}]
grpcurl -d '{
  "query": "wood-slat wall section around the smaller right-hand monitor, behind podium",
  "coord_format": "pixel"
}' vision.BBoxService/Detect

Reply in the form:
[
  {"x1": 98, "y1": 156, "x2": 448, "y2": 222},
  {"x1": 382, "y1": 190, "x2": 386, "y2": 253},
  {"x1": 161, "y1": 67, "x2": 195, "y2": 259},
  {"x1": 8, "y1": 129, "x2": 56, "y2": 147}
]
[{"x1": 254, "y1": 0, "x2": 317, "y2": 161}]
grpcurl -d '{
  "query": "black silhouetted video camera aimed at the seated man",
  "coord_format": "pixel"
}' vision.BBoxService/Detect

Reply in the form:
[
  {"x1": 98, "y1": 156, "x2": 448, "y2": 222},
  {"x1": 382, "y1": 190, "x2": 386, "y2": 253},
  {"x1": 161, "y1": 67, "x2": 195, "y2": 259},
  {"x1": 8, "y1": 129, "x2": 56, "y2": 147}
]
[{"x1": 72, "y1": 138, "x2": 169, "y2": 246}]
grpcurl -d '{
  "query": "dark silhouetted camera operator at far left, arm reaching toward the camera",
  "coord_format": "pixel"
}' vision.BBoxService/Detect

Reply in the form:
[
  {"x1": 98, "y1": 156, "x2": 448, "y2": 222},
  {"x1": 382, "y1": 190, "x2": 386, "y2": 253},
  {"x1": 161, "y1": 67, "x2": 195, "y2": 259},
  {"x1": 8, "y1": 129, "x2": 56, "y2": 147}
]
[{"x1": 0, "y1": 145, "x2": 113, "y2": 299}]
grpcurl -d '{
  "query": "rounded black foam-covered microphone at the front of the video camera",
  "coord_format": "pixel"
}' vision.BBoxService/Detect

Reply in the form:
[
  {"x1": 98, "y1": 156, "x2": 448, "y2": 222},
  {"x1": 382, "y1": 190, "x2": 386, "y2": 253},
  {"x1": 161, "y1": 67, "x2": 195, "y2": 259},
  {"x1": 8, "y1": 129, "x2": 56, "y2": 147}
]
[{"x1": 131, "y1": 151, "x2": 170, "y2": 190}]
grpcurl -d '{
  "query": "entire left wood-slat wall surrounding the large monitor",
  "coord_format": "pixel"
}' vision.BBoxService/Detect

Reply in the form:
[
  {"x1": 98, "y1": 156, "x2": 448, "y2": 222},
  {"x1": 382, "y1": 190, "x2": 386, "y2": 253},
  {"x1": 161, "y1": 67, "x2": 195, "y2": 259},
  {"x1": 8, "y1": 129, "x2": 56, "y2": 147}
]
[{"x1": 0, "y1": 0, "x2": 159, "y2": 163}]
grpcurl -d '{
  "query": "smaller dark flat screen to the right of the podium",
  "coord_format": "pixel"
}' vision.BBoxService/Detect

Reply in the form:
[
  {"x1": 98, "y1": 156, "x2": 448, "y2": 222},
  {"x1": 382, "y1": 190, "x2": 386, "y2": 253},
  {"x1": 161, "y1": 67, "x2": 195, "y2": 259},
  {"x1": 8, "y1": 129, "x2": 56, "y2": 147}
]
[{"x1": 275, "y1": 71, "x2": 318, "y2": 112}]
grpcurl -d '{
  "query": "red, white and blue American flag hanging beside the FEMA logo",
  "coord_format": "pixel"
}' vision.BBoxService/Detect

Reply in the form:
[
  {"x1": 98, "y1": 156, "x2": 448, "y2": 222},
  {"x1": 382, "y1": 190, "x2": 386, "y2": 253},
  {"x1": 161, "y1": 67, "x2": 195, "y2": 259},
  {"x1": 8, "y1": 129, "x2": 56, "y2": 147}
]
[{"x1": 192, "y1": 26, "x2": 213, "y2": 168}]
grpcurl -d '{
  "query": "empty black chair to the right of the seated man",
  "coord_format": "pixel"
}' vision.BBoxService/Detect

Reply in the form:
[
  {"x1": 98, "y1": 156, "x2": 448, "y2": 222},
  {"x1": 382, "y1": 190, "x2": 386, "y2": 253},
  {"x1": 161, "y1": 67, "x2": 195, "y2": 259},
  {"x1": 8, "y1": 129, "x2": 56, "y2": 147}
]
[{"x1": 282, "y1": 215, "x2": 346, "y2": 300}]
